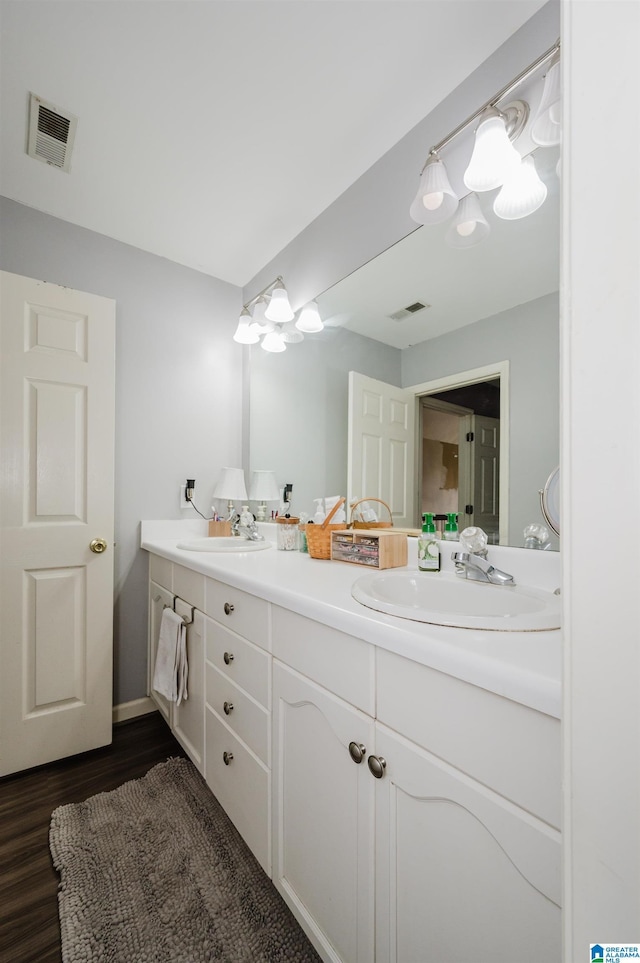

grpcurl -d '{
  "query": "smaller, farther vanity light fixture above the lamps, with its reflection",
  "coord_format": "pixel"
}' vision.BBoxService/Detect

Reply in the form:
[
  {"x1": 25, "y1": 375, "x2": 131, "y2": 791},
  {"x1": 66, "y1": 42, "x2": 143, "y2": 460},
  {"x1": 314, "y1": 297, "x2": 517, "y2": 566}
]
[{"x1": 233, "y1": 277, "x2": 324, "y2": 352}]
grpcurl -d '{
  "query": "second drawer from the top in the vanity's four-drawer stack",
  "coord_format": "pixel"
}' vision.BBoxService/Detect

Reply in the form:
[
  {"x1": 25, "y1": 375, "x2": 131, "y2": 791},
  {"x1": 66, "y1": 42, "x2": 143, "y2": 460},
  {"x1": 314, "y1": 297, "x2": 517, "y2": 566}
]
[{"x1": 205, "y1": 619, "x2": 271, "y2": 708}]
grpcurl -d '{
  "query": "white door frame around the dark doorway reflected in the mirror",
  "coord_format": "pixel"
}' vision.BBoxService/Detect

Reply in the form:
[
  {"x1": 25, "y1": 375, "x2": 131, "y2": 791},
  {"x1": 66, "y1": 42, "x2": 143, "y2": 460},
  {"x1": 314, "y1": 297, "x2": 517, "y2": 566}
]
[{"x1": 406, "y1": 361, "x2": 510, "y2": 545}]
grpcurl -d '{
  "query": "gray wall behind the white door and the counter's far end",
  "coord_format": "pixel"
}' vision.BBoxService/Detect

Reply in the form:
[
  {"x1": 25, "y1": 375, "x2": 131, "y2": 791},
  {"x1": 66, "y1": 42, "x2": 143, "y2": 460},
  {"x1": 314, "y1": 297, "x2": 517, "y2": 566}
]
[{"x1": 0, "y1": 198, "x2": 242, "y2": 705}]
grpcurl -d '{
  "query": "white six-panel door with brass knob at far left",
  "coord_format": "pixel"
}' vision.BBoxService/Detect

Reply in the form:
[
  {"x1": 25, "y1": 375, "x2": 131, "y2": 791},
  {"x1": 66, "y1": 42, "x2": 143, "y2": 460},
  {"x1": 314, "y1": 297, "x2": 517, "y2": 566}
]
[{"x1": 0, "y1": 272, "x2": 115, "y2": 775}]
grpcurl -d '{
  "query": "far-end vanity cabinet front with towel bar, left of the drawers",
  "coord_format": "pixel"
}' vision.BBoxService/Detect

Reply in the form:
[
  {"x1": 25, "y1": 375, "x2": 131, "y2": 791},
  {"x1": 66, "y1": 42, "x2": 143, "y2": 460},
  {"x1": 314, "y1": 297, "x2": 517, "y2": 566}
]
[{"x1": 148, "y1": 555, "x2": 204, "y2": 773}]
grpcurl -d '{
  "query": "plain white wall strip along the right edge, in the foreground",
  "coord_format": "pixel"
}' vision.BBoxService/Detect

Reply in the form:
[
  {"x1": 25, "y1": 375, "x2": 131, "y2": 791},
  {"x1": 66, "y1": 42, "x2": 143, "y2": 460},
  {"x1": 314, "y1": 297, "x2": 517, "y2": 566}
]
[{"x1": 561, "y1": 0, "x2": 640, "y2": 948}]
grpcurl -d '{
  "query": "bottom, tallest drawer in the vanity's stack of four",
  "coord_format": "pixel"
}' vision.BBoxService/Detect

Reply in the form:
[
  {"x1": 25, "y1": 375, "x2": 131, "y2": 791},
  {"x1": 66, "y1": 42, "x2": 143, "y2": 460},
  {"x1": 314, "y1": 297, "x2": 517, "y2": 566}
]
[{"x1": 206, "y1": 709, "x2": 271, "y2": 876}]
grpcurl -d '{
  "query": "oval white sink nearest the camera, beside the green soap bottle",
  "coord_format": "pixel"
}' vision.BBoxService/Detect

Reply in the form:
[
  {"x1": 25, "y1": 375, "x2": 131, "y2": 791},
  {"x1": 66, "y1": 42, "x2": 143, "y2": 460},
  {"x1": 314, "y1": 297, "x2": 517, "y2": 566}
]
[{"x1": 351, "y1": 572, "x2": 561, "y2": 632}]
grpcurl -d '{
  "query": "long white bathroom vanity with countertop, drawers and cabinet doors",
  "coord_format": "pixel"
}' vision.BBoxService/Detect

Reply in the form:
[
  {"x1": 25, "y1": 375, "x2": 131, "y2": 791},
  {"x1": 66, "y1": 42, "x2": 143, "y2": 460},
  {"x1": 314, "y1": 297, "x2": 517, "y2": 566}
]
[{"x1": 142, "y1": 522, "x2": 561, "y2": 963}]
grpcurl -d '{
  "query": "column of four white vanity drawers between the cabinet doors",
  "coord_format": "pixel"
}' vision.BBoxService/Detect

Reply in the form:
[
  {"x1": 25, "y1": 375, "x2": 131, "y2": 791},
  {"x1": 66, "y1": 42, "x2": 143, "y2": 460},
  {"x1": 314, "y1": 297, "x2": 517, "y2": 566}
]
[{"x1": 205, "y1": 579, "x2": 271, "y2": 875}]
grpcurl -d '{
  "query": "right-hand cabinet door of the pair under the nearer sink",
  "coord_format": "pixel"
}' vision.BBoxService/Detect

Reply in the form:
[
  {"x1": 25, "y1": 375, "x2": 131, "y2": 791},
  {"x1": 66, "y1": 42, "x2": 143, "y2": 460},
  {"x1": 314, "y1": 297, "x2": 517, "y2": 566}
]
[{"x1": 376, "y1": 724, "x2": 561, "y2": 963}]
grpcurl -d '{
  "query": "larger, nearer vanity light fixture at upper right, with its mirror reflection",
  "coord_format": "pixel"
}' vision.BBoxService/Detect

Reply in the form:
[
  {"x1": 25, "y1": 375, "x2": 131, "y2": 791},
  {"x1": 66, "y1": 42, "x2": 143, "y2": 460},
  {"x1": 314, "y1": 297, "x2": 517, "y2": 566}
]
[{"x1": 409, "y1": 41, "x2": 560, "y2": 247}]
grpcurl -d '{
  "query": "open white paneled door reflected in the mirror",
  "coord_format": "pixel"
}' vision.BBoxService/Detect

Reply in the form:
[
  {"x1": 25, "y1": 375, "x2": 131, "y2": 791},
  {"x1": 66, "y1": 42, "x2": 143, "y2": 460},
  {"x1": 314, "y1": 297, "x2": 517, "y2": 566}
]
[{"x1": 347, "y1": 371, "x2": 416, "y2": 527}]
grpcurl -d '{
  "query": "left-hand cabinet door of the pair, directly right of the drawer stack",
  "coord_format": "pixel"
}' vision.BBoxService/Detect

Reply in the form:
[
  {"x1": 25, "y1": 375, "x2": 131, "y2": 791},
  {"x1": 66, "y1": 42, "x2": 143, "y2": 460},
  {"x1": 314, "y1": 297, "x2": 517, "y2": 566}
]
[{"x1": 273, "y1": 662, "x2": 375, "y2": 963}]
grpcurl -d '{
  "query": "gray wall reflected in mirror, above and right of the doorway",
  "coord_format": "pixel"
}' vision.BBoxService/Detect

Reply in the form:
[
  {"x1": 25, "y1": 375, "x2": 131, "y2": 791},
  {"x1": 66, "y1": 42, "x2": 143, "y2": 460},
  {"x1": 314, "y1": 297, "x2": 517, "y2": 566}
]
[{"x1": 402, "y1": 294, "x2": 560, "y2": 547}]
